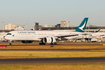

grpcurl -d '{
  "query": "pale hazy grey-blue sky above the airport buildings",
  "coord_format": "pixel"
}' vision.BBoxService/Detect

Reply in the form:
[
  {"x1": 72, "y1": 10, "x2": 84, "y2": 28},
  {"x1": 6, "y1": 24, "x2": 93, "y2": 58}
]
[{"x1": 0, "y1": 0, "x2": 105, "y2": 29}]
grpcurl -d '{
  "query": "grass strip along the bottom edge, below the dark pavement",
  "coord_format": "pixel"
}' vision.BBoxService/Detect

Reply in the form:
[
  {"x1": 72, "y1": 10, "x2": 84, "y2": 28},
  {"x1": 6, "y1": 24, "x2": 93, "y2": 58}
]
[{"x1": 0, "y1": 64, "x2": 105, "y2": 70}]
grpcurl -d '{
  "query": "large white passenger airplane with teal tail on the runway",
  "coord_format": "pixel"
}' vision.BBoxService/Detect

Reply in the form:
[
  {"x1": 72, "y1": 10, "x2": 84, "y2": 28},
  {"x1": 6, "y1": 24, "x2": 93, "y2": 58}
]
[{"x1": 4, "y1": 17, "x2": 88, "y2": 45}]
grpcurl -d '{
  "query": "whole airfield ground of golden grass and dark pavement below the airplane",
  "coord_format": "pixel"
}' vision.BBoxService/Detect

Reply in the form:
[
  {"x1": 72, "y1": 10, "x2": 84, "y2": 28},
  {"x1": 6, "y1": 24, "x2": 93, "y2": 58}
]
[{"x1": 0, "y1": 42, "x2": 105, "y2": 70}]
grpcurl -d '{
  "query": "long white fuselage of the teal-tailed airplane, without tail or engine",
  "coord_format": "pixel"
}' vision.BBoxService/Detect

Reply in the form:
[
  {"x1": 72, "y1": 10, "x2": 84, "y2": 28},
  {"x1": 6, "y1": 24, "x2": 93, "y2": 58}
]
[{"x1": 5, "y1": 30, "x2": 80, "y2": 40}]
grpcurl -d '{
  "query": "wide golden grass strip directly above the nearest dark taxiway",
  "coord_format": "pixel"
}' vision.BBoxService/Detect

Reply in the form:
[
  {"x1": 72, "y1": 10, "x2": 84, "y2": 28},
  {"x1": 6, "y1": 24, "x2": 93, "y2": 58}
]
[{"x1": 0, "y1": 51, "x2": 105, "y2": 59}]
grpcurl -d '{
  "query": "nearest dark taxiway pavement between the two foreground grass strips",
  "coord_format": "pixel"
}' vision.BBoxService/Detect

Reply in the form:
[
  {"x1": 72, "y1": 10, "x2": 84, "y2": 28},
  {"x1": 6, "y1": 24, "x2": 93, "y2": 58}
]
[{"x1": 0, "y1": 57, "x2": 105, "y2": 65}]
